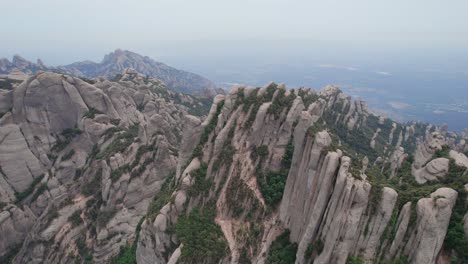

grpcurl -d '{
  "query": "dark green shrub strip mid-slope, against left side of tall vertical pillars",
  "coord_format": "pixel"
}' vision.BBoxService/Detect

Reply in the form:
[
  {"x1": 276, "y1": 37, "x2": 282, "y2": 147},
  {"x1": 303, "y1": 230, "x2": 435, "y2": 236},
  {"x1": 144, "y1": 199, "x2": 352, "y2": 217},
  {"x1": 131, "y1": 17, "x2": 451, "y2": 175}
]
[{"x1": 257, "y1": 138, "x2": 294, "y2": 208}]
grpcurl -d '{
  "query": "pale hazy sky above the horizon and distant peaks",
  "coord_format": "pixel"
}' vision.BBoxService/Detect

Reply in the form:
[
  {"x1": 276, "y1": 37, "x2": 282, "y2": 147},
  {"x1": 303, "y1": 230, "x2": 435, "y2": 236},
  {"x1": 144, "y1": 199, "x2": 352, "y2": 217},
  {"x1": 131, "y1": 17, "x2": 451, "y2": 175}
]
[{"x1": 0, "y1": 0, "x2": 468, "y2": 65}]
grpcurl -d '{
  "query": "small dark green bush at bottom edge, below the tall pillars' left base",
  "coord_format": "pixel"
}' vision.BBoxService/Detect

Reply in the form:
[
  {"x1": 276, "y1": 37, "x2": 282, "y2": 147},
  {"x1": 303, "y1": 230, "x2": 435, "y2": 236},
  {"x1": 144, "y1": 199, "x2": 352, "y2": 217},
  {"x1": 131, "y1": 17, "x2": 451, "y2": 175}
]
[{"x1": 266, "y1": 231, "x2": 297, "y2": 264}]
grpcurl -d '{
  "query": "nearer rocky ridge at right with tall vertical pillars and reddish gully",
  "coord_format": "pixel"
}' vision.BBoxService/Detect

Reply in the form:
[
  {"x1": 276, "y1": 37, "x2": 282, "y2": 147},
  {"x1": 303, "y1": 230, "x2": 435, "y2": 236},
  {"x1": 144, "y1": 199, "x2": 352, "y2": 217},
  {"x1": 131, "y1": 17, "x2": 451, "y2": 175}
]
[{"x1": 137, "y1": 84, "x2": 466, "y2": 263}]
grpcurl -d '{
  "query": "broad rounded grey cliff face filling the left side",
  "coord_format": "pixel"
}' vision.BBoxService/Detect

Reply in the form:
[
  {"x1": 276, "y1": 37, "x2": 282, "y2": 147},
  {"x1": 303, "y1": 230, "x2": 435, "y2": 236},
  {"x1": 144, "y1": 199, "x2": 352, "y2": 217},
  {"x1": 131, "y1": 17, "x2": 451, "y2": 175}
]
[{"x1": 0, "y1": 69, "x2": 208, "y2": 263}]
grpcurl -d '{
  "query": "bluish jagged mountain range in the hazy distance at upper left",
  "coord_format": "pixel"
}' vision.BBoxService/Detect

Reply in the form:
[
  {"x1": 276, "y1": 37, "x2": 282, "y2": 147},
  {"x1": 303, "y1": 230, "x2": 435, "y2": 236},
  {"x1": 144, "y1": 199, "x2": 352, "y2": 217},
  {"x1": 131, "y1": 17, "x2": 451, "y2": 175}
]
[{"x1": 0, "y1": 49, "x2": 216, "y2": 95}]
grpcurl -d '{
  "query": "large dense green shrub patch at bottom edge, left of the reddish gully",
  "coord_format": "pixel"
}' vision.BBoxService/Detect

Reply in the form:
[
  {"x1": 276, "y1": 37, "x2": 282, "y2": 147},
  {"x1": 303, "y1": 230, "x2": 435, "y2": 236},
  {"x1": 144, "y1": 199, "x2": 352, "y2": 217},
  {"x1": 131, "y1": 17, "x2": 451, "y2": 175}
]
[{"x1": 175, "y1": 204, "x2": 228, "y2": 263}]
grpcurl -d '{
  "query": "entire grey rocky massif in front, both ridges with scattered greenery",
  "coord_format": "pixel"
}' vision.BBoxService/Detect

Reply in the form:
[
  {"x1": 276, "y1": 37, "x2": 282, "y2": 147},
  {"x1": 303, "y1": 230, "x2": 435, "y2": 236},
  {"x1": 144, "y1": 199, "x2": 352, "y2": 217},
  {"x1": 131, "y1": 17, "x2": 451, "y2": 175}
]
[{"x1": 0, "y1": 69, "x2": 468, "y2": 264}]
